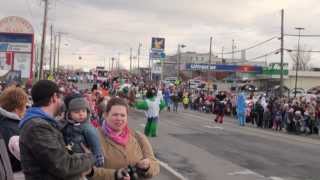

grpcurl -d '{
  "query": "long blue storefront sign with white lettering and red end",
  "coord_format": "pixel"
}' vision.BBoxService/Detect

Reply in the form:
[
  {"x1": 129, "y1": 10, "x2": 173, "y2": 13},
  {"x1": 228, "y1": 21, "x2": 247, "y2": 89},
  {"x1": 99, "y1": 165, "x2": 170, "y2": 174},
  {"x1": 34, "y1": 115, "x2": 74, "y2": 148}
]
[{"x1": 186, "y1": 64, "x2": 262, "y2": 74}]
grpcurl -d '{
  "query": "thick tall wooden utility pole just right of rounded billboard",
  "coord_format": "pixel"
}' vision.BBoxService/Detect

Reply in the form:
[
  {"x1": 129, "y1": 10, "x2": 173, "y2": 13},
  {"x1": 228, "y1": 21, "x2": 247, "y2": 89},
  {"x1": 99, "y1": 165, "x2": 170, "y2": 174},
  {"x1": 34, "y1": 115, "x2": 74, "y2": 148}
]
[{"x1": 40, "y1": 0, "x2": 48, "y2": 79}]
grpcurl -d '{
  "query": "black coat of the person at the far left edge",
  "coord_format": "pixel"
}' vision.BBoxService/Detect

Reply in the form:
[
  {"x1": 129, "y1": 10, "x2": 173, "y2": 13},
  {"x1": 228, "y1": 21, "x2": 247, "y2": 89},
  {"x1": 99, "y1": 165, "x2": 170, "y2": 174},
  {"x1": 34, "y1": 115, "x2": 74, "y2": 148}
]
[{"x1": 0, "y1": 108, "x2": 21, "y2": 172}]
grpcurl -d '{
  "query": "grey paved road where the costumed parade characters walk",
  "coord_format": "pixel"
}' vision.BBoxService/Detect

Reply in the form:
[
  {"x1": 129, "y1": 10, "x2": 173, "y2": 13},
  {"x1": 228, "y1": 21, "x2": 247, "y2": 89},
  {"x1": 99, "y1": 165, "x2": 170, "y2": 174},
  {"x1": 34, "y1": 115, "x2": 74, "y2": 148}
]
[{"x1": 130, "y1": 108, "x2": 320, "y2": 180}]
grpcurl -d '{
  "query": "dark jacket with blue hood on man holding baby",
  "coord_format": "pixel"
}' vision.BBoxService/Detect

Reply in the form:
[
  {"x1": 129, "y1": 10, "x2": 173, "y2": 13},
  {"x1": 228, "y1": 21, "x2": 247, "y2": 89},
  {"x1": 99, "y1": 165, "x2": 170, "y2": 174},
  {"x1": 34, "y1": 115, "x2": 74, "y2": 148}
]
[{"x1": 19, "y1": 108, "x2": 94, "y2": 180}]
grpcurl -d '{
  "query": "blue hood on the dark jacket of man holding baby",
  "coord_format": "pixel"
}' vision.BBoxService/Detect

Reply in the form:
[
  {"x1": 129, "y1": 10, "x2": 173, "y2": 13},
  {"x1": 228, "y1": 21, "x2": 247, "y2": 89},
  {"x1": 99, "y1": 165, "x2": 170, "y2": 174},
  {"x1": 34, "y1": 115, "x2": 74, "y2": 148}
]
[{"x1": 19, "y1": 107, "x2": 57, "y2": 128}]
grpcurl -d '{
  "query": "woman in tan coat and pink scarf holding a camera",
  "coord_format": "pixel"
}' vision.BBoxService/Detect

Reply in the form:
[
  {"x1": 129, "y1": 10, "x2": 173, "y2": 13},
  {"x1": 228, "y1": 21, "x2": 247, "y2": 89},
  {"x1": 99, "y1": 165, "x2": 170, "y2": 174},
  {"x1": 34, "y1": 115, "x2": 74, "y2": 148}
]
[{"x1": 88, "y1": 98, "x2": 160, "y2": 180}]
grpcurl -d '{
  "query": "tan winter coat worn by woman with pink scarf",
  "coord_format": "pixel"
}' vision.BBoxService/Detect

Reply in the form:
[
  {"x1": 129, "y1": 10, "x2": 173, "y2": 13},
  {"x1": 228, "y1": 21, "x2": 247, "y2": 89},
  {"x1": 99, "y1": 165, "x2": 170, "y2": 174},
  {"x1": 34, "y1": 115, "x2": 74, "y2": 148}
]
[{"x1": 92, "y1": 129, "x2": 160, "y2": 180}]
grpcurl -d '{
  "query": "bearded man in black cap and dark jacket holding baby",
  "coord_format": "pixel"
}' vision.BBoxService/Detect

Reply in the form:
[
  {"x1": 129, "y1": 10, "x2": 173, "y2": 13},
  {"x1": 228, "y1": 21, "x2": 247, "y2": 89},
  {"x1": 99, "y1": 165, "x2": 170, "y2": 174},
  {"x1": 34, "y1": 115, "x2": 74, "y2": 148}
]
[{"x1": 19, "y1": 80, "x2": 94, "y2": 180}]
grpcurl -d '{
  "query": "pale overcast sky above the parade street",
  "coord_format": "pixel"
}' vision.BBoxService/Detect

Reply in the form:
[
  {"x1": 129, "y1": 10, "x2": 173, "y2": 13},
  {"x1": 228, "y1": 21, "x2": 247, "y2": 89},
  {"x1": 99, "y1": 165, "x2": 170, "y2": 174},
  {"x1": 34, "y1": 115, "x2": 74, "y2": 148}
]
[{"x1": 0, "y1": 0, "x2": 320, "y2": 67}]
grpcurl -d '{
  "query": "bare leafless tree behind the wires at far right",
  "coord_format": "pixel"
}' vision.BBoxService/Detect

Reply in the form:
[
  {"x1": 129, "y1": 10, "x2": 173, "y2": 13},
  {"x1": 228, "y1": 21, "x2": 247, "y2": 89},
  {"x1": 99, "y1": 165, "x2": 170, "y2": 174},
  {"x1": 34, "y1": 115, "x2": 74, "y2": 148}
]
[{"x1": 289, "y1": 45, "x2": 312, "y2": 71}]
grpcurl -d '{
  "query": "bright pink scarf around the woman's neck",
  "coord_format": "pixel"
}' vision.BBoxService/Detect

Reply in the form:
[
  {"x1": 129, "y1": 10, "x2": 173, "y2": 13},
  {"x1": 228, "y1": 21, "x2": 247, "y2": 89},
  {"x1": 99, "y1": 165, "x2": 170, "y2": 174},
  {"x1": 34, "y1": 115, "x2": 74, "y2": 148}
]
[{"x1": 103, "y1": 121, "x2": 130, "y2": 146}]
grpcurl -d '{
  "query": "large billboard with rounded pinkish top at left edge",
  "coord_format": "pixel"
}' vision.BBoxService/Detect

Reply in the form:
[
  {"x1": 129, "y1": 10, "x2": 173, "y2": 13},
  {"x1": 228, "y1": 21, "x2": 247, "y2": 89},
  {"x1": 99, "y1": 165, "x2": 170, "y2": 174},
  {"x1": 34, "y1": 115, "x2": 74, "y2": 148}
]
[{"x1": 0, "y1": 16, "x2": 34, "y2": 78}]
